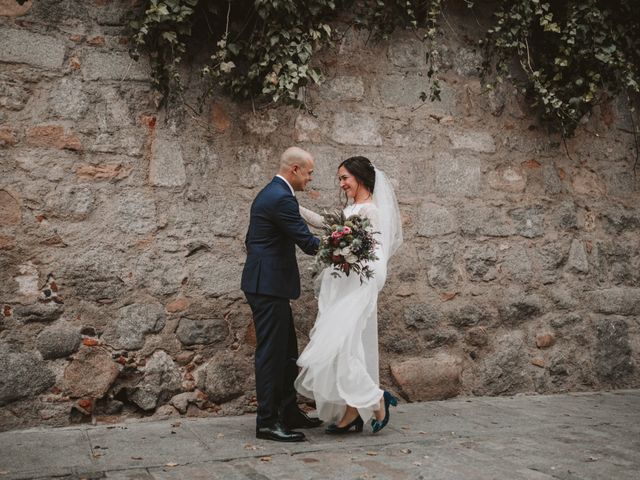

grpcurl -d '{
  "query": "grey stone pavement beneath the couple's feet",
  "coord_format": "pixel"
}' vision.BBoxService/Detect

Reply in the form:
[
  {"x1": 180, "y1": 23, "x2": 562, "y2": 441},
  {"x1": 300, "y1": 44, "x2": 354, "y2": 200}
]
[{"x1": 0, "y1": 390, "x2": 640, "y2": 480}]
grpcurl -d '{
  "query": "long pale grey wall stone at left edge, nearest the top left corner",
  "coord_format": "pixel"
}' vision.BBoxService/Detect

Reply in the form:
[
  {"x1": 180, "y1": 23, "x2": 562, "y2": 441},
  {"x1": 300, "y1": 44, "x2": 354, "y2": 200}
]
[{"x1": 0, "y1": 27, "x2": 65, "y2": 68}]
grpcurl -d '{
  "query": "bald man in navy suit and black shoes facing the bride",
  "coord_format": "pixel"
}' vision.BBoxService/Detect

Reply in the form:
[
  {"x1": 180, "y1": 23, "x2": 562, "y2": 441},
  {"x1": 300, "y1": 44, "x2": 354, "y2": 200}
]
[{"x1": 241, "y1": 147, "x2": 322, "y2": 442}]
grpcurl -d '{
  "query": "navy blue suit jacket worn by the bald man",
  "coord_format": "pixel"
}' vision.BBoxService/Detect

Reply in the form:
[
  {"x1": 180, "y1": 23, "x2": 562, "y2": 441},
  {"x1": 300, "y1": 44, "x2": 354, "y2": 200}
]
[{"x1": 241, "y1": 177, "x2": 320, "y2": 299}]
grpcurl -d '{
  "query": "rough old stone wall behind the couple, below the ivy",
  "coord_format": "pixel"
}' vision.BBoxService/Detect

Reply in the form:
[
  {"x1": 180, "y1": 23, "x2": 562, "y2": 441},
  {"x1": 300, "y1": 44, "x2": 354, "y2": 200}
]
[{"x1": 0, "y1": 0, "x2": 640, "y2": 429}]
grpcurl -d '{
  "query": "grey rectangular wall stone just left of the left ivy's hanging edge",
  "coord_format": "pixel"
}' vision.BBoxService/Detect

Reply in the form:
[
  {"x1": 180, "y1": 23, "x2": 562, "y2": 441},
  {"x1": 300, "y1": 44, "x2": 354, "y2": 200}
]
[{"x1": 81, "y1": 51, "x2": 151, "y2": 82}]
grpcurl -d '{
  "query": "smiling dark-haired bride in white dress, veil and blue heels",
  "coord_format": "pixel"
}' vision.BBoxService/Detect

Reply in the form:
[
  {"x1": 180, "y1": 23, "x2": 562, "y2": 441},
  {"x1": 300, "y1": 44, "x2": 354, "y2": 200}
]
[{"x1": 295, "y1": 156, "x2": 402, "y2": 433}]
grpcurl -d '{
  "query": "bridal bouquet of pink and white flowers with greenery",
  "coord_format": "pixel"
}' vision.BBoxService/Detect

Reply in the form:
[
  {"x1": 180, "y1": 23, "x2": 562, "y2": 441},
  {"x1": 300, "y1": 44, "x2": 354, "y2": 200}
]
[{"x1": 316, "y1": 210, "x2": 378, "y2": 283}]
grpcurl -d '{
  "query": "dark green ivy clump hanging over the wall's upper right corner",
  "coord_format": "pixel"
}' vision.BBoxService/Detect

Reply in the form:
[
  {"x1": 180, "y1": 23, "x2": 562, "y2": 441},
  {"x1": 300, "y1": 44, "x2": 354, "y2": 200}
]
[{"x1": 484, "y1": 0, "x2": 640, "y2": 136}]
